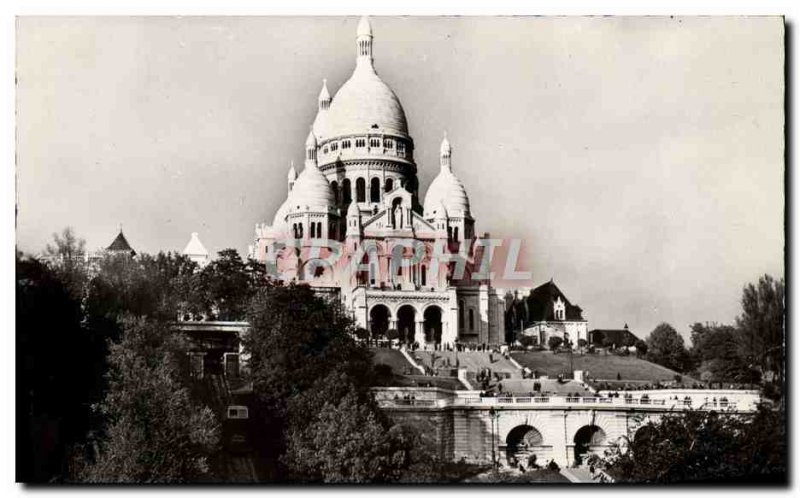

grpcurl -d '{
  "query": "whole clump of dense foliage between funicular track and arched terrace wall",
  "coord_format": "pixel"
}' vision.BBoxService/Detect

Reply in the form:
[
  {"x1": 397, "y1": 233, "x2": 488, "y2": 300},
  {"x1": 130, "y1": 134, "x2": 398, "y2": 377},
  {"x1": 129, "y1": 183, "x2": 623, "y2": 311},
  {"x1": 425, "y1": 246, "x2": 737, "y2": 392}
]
[{"x1": 244, "y1": 285, "x2": 407, "y2": 482}]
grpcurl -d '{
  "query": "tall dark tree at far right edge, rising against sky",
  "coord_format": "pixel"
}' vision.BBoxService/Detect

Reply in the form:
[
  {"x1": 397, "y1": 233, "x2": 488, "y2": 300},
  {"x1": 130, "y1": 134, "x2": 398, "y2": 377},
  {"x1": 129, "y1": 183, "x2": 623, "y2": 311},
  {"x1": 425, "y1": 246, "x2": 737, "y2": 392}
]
[{"x1": 736, "y1": 275, "x2": 785, "y2": 392}]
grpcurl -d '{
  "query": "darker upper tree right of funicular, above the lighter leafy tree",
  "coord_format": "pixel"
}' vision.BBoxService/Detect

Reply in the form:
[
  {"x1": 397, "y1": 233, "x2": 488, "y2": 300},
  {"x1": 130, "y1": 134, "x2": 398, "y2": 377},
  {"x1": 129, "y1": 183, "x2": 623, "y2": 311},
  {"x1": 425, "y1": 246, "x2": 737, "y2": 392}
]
[{"x1": 243, "y1": 284, "x2": 374, "y2": 475}]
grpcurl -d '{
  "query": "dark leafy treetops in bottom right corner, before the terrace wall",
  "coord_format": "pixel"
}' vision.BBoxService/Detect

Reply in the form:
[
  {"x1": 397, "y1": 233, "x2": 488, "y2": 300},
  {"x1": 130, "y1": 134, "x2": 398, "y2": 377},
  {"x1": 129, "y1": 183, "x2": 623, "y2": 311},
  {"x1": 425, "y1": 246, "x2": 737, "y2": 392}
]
[{"x1": 592, "y1": 406, "x2": 787, "y2": 483}]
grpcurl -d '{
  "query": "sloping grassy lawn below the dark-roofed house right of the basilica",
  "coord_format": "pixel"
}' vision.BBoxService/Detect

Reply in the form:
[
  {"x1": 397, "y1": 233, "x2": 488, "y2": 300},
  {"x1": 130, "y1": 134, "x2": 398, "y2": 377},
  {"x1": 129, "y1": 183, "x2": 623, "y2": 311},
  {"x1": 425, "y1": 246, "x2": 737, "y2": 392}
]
[{"x1": 511, "y1": 351, "x2": 677, "y2": 382}]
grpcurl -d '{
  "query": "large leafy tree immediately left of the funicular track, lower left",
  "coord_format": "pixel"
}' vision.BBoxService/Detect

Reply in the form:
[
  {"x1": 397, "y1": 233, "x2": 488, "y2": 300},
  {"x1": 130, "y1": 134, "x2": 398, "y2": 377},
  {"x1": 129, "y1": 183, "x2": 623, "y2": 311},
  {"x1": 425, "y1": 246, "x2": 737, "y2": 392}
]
[{"x1": 82, "y1": 317, "x2": 220, "y2": 483}]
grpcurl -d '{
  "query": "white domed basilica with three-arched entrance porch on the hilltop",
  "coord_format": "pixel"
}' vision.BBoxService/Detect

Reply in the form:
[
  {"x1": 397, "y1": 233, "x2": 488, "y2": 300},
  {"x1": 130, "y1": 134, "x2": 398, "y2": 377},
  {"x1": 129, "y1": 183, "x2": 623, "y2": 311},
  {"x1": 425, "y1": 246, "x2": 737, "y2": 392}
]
[{"x1": 250, "y1": 18, "x2": 505, "y2": 347}]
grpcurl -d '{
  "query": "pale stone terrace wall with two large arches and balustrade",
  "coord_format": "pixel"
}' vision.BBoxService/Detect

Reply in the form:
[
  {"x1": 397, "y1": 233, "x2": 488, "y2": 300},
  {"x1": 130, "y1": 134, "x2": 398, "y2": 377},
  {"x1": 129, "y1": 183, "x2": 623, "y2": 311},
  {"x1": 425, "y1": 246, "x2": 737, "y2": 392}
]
[{"x1": 376, "y1": 388, "x2": 760, "y2": 467}]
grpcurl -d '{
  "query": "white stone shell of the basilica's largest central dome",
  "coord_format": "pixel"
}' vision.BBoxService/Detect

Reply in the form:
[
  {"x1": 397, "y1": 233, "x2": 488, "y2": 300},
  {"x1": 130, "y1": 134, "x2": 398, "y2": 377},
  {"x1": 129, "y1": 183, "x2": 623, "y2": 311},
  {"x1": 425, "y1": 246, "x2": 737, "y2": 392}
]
[{"x1": 324, "y1": 63, "x2": 408, "y2": 139}]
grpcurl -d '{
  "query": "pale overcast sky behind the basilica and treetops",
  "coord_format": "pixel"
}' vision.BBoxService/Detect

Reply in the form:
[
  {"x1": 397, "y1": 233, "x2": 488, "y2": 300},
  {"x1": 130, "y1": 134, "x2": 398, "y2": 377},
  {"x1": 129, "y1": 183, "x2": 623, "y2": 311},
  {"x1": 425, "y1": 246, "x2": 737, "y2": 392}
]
[{"x1": 17, "y1": 17, "x2": 784, "y2": 336}]
